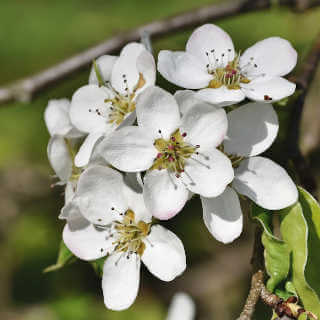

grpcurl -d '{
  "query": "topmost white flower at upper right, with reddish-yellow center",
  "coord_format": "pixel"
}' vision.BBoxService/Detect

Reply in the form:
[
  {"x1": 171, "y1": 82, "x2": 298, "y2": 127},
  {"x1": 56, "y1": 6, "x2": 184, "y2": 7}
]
[{"x1": 158, "y1": 24, "x2": 297, "y2": 106}]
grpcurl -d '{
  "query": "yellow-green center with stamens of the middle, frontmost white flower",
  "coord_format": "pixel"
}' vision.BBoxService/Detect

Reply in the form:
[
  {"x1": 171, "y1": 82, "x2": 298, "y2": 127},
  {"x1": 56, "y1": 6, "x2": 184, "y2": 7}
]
[{"x1": 150, "y1": 129, "x2": 200, "y2": 175}]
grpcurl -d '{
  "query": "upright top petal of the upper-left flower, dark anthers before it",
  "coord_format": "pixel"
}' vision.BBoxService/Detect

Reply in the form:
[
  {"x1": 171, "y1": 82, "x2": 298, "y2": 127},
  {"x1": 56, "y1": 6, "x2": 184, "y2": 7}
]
[{"x1": 111, "y1": 42, "x2": 146, "y2": 95}]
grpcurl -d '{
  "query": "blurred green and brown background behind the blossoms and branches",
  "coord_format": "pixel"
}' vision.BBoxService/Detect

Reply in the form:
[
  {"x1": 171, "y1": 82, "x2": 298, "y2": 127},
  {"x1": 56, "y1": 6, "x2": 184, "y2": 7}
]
[{"x1": 0, "y1": 0, "x2": 320, "y2": 320}]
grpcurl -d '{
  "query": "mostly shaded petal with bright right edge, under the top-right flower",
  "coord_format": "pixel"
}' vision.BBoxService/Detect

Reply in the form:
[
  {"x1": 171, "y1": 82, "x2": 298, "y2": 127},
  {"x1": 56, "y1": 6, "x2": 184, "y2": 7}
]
[{"x1": 224, "y1": 103, "x2": 279, "y2": 157}]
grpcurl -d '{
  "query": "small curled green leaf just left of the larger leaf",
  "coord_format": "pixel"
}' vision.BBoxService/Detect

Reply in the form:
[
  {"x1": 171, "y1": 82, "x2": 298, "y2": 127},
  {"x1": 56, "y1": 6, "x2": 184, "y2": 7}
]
[{"x1": 262, "y1": 232, "x2": 290, "y2": 292}]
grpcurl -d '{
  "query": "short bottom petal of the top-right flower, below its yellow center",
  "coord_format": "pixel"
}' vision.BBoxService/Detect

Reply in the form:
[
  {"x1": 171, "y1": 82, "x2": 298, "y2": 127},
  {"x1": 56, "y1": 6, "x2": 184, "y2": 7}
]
[{"x1": 196, "y1": 86, "x2": 245, "y2": 107}]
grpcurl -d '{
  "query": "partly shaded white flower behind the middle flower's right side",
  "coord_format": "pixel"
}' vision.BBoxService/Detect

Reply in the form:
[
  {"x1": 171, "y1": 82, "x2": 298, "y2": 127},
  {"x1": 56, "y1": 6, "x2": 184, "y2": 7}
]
[{"x1": 201, "y1": 103, "x2": 298, "y2": 243}]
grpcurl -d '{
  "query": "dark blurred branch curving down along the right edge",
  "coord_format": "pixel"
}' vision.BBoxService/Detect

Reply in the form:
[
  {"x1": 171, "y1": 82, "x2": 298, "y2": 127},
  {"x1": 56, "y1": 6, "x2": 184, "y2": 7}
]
[{"x1": 287, "y1": 34, "x2": 320, "y2": 193}]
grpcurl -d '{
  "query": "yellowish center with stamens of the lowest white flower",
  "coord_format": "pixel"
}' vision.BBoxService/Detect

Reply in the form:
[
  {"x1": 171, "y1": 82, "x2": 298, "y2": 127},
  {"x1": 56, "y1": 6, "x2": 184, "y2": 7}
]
[{"x1": 113, "y1": 209, "x2": 151, "y2": 256}]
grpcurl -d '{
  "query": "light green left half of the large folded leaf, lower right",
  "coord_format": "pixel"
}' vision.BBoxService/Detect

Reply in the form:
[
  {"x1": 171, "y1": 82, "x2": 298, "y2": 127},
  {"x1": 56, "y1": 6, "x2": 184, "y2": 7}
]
[{"x1": 280, "y1": 191, "x2": 320, "y2": 317}]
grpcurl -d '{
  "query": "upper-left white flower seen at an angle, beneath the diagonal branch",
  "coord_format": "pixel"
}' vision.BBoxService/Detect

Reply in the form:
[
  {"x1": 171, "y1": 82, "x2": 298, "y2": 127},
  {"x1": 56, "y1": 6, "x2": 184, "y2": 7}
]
[{"x1": 70, "y1": 43, "x2": 156, "y2": 167}]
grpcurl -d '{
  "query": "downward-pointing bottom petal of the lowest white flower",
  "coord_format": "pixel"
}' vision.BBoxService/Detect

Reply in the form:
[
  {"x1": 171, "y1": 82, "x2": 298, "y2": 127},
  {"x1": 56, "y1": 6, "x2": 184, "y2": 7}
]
[{"x1": 102, "y1": 253, "x2": 141, "y2": 311}]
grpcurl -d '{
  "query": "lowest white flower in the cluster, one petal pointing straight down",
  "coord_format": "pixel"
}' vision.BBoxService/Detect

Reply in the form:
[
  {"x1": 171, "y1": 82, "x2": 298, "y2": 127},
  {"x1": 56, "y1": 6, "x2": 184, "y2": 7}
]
[{"x1": 60, "y1": 166, "x2": 186, "y2": 310}]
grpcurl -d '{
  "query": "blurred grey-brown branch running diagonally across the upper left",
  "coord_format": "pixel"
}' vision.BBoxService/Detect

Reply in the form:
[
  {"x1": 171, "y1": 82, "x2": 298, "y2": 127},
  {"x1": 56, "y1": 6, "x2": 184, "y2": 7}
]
[{"x1": 0, "y1": 0, "x2": 270, "y2": 104}]
